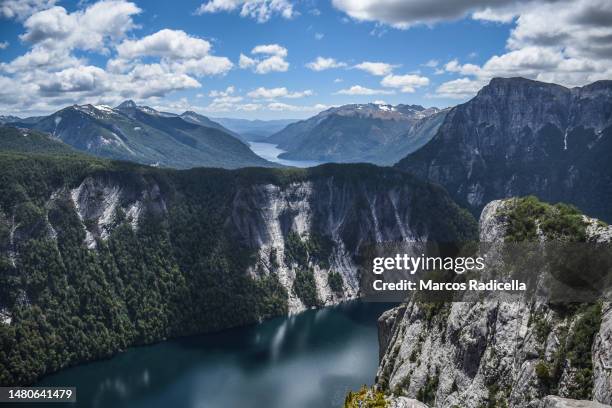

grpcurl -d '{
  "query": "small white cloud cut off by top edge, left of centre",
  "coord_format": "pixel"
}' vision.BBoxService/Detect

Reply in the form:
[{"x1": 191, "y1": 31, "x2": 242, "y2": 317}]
[{"x1": 196, "y1": 0, "x2": 297, "y2": 23}]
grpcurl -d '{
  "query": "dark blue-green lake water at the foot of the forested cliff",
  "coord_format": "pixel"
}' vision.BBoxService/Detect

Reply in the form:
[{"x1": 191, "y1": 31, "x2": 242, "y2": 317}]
[{"x1": 35, "y1": 301, "x2": 392, "y2": 408}]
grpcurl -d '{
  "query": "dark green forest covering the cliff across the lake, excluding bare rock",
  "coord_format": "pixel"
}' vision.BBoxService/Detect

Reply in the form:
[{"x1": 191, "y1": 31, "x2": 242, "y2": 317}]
[{"x1": 0, "y1": 140, "x2": 476, "y2": 385}]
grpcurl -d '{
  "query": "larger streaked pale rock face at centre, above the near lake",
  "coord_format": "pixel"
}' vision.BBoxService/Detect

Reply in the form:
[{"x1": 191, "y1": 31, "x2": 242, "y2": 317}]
[{"x1": 229, "y1": 169, "x2": 474, "y2": 312}]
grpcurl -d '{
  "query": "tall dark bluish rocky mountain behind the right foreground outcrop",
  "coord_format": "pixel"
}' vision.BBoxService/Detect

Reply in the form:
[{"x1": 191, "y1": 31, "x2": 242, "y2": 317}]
[{"x1": 397, "y1": 78, "x2": 612, "y2": 221}]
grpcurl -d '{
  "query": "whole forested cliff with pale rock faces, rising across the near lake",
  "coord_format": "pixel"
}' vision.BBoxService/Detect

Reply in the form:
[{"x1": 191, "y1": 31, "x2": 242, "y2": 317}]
[{"x1": 0, "y1": 154, "x2": 476, "y2": 384}]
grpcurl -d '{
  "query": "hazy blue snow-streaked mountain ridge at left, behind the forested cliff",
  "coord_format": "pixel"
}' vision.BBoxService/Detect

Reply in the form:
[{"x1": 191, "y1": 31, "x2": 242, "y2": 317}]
[{"x1": 9, "y1": 101, "x2": 276, "y2": 169}]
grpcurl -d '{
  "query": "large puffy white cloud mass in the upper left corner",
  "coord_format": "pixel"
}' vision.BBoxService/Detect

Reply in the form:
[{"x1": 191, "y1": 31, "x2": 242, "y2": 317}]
[{"x1": 0, "y1": 0, "x2": 233, "y2": 113}]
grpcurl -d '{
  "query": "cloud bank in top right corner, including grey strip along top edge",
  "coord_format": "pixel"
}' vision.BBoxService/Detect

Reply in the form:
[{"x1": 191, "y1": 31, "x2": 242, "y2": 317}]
[{"x1": 333, "y1": 0, "x2": 612, "y2": 98}]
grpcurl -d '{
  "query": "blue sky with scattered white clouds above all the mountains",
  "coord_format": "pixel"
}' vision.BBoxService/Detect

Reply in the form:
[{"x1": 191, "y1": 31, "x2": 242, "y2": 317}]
[{"x1": 0, "y1": 0, "x2": 612, "y2": 119}]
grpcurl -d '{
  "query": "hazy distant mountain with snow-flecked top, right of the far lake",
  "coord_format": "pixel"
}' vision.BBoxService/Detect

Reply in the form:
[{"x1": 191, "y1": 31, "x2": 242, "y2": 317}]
[{"x1": 266, "y1": 103, "x2": 447, "y2": 165}]
